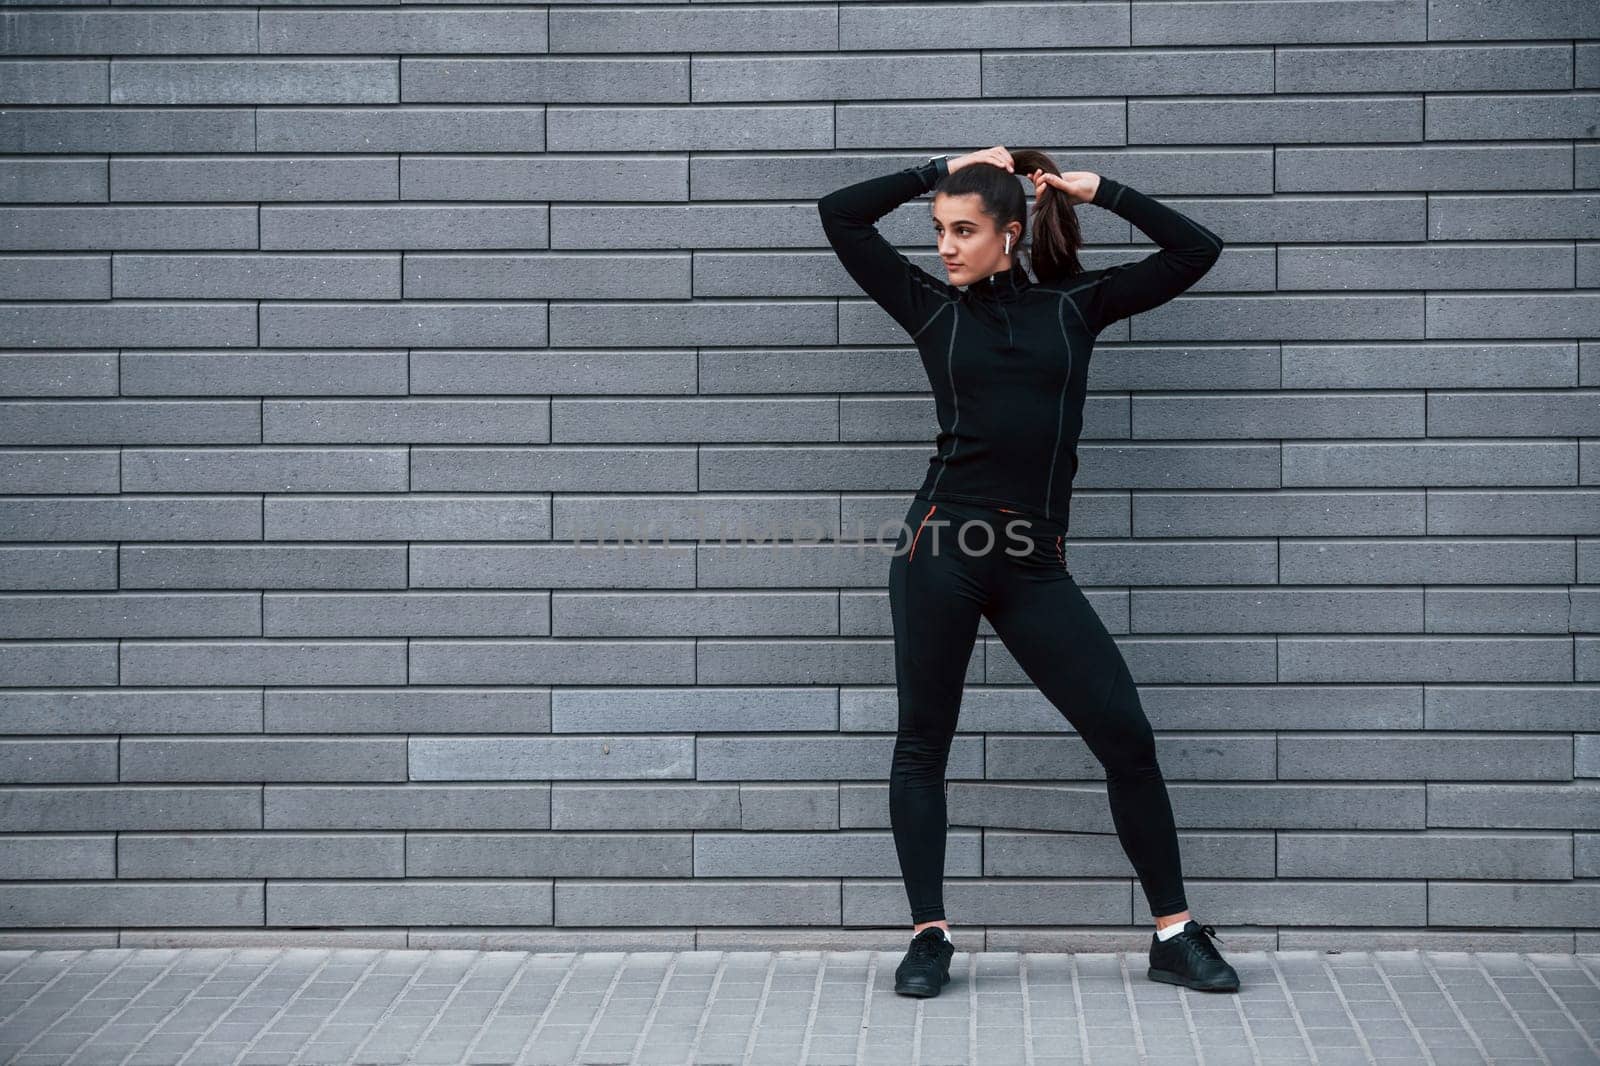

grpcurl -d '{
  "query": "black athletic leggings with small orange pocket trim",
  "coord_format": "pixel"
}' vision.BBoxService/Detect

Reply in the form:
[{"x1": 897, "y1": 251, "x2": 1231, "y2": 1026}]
[{"x1": 890, "y1": 496, "x2": 1189, "y2": 924}]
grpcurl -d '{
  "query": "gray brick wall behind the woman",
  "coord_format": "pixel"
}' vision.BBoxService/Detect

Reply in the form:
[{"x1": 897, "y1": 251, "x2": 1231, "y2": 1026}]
[{"x1": 0, "y1": 0, "x2": 1600, "y2": 951}]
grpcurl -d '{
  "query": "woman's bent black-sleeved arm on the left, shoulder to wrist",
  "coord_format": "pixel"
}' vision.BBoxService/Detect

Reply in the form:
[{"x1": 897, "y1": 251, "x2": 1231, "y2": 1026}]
[{"x1": 816, "y1": 155, "x2": 957, "y2": 338}]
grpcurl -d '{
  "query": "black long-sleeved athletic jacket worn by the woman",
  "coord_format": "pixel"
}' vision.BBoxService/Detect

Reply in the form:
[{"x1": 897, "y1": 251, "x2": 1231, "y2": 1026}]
[{"x1": 816, "y1": 157, "x2": 1222, "y2": 533}]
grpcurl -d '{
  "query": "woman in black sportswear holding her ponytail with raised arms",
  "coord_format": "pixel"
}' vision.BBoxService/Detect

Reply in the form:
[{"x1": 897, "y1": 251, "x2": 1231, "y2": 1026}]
[{"x1": 818, "y1": 146, "x2": 1238, "y2": 996}]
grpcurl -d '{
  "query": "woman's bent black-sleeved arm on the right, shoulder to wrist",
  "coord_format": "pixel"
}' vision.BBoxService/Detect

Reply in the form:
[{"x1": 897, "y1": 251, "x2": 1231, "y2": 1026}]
[{"x1": 1078, "y1": 174, "x2": 1222, "y2": 333}]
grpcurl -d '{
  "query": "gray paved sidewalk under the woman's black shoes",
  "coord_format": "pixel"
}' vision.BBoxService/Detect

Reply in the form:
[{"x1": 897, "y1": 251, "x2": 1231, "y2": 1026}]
[{"x1": 0, "y1": 948, "x2": 1600, "y2": 1066}]
